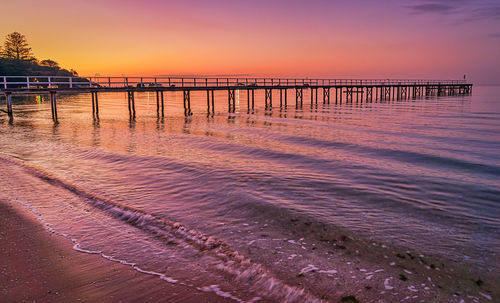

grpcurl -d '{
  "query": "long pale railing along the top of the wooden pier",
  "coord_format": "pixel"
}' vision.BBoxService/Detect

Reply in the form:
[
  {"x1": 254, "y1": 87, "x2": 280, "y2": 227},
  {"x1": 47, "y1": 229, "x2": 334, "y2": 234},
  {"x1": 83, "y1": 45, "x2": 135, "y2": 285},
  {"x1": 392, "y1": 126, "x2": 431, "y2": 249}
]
[{"x1": 0, "y1": 76, "x2": 466, "y2": 90}]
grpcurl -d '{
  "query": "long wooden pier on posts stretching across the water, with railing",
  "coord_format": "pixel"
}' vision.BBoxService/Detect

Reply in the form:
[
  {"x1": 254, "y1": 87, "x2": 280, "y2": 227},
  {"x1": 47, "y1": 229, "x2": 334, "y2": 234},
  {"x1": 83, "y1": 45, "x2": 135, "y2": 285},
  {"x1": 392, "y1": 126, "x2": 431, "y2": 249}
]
[{"x1": 0, "y1": 76, "x2": 472, "y2": 121}]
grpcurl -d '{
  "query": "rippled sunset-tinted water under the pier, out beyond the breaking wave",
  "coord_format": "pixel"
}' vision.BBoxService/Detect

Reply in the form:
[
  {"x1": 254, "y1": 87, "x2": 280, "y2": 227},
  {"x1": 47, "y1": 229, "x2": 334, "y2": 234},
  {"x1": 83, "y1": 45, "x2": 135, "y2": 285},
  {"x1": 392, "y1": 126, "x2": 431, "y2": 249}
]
[{"x1": 0, "y1": 87, "x2": 500, "y2": 300}]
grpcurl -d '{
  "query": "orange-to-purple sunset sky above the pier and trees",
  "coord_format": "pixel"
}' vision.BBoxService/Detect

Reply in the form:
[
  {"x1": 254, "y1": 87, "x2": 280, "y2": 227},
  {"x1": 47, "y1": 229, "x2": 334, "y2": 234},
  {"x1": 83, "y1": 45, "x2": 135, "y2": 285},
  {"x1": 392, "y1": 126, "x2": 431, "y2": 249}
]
[{"x1": 0, "y1": 0, "x2": 500, "y2": 84}]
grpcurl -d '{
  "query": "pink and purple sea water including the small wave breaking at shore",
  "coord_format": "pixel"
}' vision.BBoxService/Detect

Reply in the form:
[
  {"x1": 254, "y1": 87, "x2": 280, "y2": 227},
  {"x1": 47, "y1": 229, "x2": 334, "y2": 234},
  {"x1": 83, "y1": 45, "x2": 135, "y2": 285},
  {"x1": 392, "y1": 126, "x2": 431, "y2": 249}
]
[{"x1": 0, "y1": 86, "x2": 500, "y2": 301}]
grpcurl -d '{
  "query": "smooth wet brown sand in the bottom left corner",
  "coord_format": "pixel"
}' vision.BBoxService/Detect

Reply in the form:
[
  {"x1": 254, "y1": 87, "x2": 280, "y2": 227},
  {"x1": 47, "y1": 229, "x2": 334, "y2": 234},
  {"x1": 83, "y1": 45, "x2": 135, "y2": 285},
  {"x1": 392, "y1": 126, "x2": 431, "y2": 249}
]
[{"x1": 0, "y1": 200, "x2": 230, "y2": 302}]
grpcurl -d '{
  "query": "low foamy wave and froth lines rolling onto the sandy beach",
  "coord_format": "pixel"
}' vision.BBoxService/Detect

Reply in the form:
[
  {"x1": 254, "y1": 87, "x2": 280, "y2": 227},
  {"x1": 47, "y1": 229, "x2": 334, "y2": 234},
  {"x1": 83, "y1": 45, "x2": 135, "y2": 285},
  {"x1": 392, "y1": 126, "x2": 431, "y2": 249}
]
[{"x1": 0, "y1": 157, "x2": 323, "y2": 302}]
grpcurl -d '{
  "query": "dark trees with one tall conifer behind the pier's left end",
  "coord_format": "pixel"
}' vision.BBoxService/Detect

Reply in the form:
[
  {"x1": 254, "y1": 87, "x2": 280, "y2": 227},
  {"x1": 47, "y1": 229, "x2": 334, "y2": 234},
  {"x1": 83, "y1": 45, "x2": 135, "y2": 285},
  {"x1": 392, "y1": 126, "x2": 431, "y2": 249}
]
[{"x1": 0, "y1": 32, "x2": 78, "y2": 77}]
